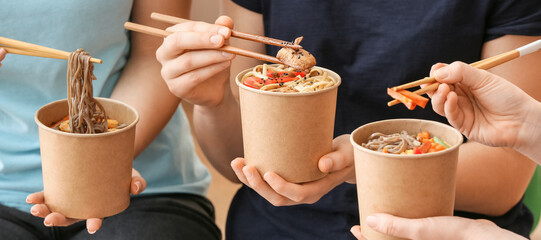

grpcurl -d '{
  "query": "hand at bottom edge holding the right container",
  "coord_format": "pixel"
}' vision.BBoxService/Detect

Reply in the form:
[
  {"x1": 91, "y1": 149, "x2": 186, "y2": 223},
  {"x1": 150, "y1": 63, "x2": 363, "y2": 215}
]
[{"x1": 351, "y1": 213, "x2": 526, "y2": 240}]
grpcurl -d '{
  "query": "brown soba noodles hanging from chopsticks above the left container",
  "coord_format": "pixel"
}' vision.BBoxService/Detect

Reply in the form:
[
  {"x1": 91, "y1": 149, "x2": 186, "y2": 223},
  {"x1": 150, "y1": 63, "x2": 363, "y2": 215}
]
[{"x1": 68, "y1": 49, "x2": 107, "y2": 134}]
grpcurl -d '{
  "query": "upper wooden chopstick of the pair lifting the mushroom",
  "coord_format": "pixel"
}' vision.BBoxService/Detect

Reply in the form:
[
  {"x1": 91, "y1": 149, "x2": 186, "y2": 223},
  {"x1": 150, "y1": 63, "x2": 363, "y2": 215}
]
[{"x1": 150, "y1": 12, "x2": 302, "y2": 49}]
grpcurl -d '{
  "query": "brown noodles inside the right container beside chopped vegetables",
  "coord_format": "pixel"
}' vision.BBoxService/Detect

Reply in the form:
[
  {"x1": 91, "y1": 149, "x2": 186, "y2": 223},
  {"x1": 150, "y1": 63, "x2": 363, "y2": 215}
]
[{"x1": 362, "y1": 131, "x2": 422, "y2": 154}]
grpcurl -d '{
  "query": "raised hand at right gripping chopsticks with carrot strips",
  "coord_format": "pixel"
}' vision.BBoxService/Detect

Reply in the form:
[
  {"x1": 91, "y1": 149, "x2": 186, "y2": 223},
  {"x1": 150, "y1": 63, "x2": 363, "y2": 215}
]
[{"x1": 431, "y1": 62, "x2": 541, "y2": 164}]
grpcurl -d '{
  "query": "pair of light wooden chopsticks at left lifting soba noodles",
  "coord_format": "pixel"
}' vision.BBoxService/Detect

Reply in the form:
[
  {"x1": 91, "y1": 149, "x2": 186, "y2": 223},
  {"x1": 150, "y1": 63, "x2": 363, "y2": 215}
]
[{"x1": 0, "y1": 37, "x2": 102, "y2": 63}]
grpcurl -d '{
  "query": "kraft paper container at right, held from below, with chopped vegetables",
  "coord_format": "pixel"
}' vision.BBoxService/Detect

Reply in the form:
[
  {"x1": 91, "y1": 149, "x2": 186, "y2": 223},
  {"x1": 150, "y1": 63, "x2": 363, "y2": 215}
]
[{"x1": 351, "y1": 119, "x2": 462, "y2": 240}]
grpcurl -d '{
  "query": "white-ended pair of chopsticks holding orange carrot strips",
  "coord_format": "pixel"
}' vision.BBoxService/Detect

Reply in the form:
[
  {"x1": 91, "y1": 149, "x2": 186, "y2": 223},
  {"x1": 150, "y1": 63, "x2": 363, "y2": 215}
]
[{"x1": 387, "y1": 40, "x2": 541, "y2": 107}]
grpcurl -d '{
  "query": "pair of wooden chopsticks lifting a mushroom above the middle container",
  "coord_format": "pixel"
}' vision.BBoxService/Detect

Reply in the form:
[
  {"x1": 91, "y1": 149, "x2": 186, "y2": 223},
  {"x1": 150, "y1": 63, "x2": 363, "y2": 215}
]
[{"x1": 124, "y1": 12, "x2": 302, "y2": 64}]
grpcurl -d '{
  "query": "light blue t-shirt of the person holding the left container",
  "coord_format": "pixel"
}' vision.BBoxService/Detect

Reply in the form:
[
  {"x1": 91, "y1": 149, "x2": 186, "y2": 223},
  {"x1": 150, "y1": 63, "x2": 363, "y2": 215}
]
[{"x1": 0, "y1": 0, "x2": 210, "y2": 212}]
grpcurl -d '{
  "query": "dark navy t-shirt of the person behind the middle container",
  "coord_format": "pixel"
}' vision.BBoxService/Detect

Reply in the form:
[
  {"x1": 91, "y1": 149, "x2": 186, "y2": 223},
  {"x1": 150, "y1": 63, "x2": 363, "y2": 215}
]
[{"x1": 226, "y1": 0, "x2": 541, "y2": 239}]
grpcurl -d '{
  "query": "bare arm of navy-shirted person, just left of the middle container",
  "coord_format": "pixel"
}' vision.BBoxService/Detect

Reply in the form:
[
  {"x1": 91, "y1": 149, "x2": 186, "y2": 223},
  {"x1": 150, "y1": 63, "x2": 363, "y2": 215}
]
[{"x1": 194, "y1": 1, "x2": 265, "y2": 182}]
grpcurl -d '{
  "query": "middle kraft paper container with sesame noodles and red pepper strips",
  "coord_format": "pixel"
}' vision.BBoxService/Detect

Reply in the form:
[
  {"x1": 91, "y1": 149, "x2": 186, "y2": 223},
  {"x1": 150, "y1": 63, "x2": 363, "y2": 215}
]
[{"x1": 236, "y1": 64, "x2": 341, "y2": 183}]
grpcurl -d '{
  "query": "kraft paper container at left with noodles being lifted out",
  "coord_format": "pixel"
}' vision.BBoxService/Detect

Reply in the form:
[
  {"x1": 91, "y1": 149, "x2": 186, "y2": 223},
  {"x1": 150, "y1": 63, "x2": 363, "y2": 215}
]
[{"x1": 35, "y1": 98, "x2": 139, "y2": 219}]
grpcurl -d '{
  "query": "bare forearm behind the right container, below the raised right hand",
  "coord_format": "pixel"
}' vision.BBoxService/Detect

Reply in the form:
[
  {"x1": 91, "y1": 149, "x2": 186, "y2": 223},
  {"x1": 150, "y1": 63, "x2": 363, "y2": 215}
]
[{"x1": 455, "y1": 142, "x2": 535, "y2": 216}]
